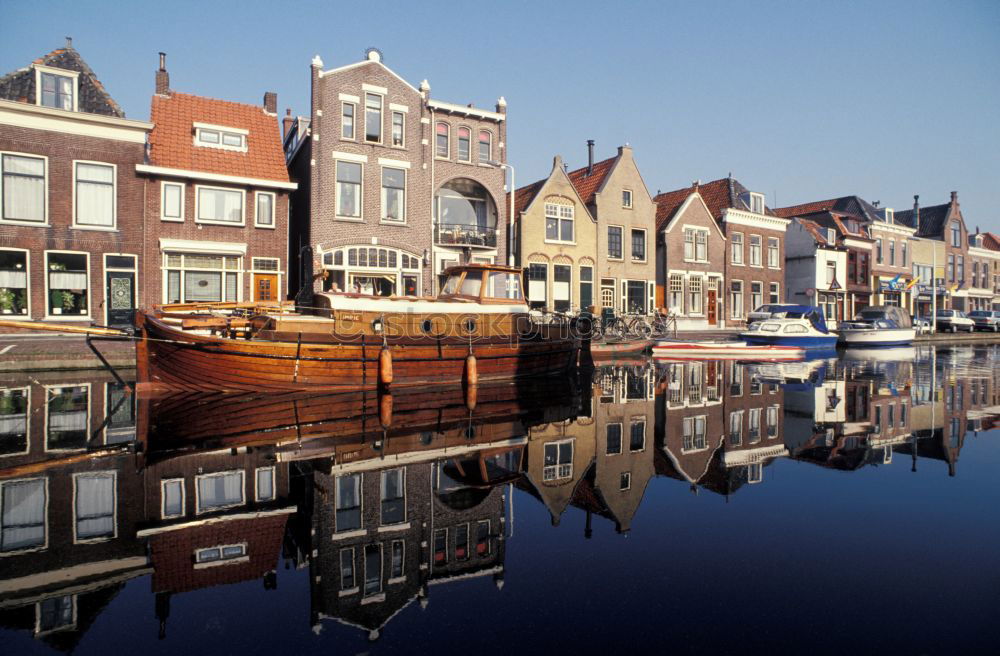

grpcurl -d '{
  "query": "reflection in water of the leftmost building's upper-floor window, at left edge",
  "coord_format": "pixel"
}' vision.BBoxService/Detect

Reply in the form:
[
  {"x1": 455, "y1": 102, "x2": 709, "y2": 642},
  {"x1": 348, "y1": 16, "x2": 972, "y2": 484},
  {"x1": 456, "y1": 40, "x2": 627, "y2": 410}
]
[{"x1": 0, "y1": 478, "x2": 49, "y2": 553}]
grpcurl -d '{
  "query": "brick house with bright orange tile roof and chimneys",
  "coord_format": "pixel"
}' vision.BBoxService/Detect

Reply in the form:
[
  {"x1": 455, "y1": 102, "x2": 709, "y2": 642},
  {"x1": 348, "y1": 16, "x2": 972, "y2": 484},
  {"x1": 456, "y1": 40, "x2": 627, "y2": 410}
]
[{"x1": 135, "y1": 53, "x2": 296, "y2": 305}]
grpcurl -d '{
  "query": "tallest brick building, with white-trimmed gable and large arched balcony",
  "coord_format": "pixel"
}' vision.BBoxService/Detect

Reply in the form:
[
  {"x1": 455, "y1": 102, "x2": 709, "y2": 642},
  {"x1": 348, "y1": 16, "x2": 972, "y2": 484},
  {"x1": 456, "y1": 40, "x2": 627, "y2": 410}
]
[{"x1": 285, "y1": 49, "x2": 508, "y2": 296}]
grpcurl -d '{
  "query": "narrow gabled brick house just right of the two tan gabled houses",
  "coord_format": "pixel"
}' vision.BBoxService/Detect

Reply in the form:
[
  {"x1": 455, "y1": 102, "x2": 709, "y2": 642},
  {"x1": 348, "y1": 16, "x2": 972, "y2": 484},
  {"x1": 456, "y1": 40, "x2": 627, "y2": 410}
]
[{"x1": 653, "y1": 182, "x2": 726, "y2": 330}]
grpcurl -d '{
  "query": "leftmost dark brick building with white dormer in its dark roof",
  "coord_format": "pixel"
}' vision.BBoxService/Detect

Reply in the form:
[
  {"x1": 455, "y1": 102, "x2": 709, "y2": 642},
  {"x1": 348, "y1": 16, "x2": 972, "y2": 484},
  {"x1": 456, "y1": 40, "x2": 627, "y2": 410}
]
[{"x1": 0, "y1": 40, "x2": 152, "y2": 325}]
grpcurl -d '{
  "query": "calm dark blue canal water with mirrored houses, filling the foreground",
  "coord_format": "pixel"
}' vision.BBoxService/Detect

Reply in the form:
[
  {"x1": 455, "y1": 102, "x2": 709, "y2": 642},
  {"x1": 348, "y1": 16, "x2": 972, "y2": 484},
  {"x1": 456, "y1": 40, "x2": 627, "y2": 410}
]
[{"x1": 0, "y1": 345, "x2": 1000, "y2": 654}]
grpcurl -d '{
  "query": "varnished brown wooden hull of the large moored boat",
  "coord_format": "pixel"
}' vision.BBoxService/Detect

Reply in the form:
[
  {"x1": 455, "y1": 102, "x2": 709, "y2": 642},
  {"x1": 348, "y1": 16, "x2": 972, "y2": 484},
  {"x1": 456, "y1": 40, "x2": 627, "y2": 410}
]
[{"x1": 136, "y1": 312, "x2": 579, "y2": 392}]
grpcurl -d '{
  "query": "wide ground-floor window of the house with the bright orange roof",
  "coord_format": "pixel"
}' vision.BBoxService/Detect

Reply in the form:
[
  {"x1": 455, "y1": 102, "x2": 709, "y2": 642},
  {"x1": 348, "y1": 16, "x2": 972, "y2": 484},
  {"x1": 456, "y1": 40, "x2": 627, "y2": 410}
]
[{"x1": 163, "y1": 253, "x2": 243, "y2": 303}]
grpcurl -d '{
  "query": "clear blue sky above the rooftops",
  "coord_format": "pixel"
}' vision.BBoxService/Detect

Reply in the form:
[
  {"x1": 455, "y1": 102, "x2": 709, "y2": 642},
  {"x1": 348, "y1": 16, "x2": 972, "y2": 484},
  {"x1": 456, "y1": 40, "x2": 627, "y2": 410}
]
[{"x1": 0, "y1": 0, "x2": 1000, "y2": 226}]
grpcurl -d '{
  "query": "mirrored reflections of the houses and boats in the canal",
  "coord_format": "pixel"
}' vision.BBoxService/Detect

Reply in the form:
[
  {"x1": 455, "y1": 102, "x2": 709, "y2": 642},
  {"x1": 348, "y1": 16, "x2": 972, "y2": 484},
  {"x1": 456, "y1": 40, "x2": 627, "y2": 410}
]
[{"x1": 0, "y1": 347, "x2": 1000, "y2": 651}]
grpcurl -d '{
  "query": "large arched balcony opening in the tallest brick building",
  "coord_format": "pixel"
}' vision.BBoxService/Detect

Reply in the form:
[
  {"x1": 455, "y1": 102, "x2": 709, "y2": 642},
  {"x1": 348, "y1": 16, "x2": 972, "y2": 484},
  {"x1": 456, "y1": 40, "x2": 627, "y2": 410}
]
[{"x1": 434, "y1": 178, "x2": 497, "y2": 247}]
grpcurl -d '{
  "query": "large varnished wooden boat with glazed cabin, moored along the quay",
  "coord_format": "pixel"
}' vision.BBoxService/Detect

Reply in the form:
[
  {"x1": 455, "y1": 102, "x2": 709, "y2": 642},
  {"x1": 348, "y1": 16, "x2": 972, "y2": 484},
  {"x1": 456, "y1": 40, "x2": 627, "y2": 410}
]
[{"x1": 136, "y1": 264, "x2": 580, "y2": 392}]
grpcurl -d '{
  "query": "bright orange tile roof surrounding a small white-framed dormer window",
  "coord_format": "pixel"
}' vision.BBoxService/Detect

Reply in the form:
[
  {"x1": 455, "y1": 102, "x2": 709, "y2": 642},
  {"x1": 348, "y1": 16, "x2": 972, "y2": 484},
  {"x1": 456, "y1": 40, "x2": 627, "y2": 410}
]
[{"x1": 149, "y1": 92, "x2": 288, "y2": 182}]
